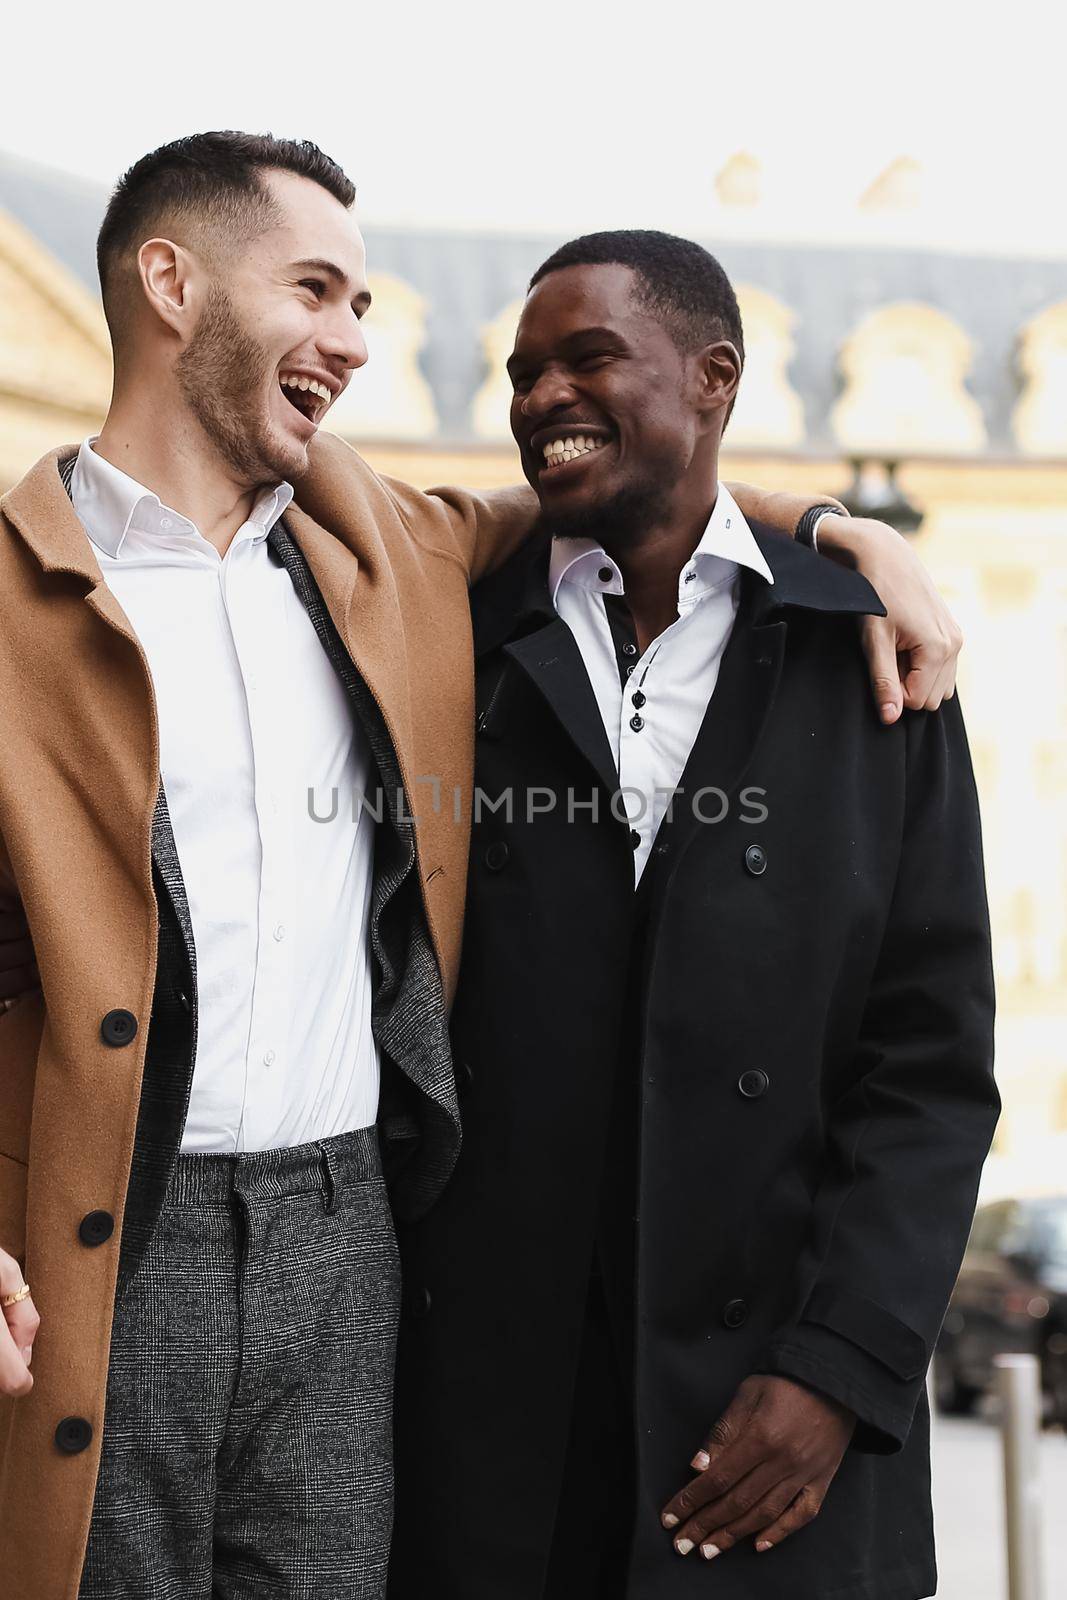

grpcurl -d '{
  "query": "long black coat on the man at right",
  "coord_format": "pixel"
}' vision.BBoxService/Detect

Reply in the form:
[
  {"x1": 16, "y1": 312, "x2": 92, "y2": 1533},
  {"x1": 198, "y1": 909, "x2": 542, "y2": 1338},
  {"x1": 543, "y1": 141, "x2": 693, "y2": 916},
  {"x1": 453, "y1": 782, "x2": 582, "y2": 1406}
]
[{"x1": 390, "y1": 528, "x2": 998, "y2": 1600}]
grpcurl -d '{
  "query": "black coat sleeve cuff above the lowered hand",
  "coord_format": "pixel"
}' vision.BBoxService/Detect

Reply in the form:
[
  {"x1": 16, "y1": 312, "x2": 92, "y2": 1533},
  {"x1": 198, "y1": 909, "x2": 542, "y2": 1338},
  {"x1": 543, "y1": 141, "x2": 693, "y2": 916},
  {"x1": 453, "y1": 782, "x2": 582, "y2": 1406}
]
[{"x1": 760, "y1": 1288, "x2": 928, "y2": 1456}]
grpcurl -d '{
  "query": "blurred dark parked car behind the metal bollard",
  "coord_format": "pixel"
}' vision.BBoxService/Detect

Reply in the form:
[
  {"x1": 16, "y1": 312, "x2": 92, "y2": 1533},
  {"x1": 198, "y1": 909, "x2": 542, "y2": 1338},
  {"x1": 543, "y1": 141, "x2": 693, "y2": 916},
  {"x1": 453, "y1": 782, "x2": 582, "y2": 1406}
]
[{"x1": 934, "y1": 1197, "x2": 1067, "y2": 1427}]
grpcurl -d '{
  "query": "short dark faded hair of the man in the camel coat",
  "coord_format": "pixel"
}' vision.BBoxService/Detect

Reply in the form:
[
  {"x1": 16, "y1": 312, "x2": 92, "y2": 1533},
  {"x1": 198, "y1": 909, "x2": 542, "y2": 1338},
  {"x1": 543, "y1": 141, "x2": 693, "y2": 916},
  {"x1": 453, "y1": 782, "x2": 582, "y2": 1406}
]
[{"x1": 96, "y1": 133, "x2": 355, "y2": 329}]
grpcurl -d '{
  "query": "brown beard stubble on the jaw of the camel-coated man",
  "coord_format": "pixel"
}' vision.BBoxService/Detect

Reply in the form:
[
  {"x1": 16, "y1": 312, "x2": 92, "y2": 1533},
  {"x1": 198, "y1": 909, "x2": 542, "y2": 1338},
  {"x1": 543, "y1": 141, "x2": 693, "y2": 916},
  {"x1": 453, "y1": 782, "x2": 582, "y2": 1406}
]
[{"x1": 174, "y1": 285, "x2": 299, "y2": 486}]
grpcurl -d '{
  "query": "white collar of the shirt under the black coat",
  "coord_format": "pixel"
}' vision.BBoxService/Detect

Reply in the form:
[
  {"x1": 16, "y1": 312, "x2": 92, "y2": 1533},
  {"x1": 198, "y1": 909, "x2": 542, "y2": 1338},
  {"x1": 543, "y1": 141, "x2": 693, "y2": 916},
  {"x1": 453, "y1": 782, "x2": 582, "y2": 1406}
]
[{"x1": 549, "y1": 483, "x2": 774, "y2": 613}]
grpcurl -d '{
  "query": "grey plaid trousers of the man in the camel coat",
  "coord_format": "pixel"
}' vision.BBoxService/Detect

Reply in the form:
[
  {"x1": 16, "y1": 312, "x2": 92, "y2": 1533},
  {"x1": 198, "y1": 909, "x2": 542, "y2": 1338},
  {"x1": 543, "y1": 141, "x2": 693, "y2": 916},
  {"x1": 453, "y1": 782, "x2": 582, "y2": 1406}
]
[{"x1": 78, "y1": 1128, "x2": 400, "y2": 1600}]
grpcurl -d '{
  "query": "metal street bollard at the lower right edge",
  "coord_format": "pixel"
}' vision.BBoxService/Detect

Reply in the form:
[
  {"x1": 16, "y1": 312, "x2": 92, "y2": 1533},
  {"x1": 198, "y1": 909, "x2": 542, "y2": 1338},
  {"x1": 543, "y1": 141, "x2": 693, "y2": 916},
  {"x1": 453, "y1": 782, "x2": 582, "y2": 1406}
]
[{"x1": 997, "y1": 1355, "x2": 1045, "y2": 1600}]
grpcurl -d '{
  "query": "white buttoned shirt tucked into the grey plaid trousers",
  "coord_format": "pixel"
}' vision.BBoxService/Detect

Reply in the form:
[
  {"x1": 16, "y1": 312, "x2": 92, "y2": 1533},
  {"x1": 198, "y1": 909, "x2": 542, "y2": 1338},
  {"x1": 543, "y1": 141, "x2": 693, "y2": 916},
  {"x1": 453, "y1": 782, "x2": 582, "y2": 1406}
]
[{"x1": 70, "y1": 440, "x2": 379, "y2": 1150}]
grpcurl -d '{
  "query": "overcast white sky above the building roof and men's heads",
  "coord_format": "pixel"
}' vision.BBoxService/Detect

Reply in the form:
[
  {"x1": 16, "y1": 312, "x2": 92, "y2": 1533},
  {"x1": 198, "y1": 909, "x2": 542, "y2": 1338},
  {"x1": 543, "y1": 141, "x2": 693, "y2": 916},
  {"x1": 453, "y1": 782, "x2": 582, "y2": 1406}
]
[{"x1": 0, "y1": 0, "x2": 1067, "y2": 248}]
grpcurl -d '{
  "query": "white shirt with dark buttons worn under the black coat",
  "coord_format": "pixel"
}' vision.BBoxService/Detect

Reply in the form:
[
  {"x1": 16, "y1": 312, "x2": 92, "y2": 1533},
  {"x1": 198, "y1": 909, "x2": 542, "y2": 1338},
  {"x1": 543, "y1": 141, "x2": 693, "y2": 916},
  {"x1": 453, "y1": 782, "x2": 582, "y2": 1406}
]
[{"x1": 549, "y1": 485, "x2": 774, "y2": 883}]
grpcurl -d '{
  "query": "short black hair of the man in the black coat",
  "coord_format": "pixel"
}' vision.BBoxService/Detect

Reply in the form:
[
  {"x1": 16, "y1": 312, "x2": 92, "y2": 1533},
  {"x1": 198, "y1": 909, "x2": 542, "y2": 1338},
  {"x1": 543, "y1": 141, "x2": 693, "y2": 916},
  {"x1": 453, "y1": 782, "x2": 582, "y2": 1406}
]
[{"x1": 530, "y1": 227, "x2": 745, "y2": 362}]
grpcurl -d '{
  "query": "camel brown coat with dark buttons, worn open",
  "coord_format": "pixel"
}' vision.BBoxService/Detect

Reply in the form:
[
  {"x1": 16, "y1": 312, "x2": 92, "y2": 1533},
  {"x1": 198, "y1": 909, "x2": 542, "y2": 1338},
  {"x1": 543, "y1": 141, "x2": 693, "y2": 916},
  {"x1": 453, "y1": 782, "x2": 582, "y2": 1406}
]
[{"x1": 0, "y1": 437, "x2": 809, "y2": 1600}]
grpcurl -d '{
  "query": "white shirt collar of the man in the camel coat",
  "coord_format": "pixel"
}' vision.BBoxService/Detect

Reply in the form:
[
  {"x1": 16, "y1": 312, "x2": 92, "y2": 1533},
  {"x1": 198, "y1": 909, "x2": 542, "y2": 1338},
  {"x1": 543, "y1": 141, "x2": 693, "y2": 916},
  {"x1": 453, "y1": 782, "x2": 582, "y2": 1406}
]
[{"x1": 70, "y1": 438, "x2": 293, "y2": 560}]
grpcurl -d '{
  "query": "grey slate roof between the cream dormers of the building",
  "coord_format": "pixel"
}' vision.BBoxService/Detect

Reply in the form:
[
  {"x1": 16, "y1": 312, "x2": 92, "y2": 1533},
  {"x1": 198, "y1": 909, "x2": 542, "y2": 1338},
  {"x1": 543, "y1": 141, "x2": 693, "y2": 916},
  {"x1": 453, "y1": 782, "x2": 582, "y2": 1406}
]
[{"x1": 0, "y1": 154, "x2": 1067, "y2": 456}]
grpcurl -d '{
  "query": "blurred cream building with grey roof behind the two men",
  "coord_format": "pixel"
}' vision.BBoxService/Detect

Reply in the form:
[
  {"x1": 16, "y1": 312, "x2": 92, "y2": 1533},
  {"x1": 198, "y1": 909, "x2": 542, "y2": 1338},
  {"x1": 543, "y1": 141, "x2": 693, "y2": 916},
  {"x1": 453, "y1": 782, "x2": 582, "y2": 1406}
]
[{"x1": 0, "y1": 150, "x2": 1067, "y2": 1197}]
